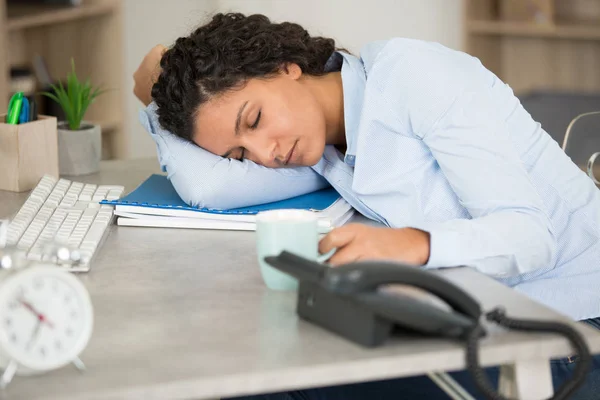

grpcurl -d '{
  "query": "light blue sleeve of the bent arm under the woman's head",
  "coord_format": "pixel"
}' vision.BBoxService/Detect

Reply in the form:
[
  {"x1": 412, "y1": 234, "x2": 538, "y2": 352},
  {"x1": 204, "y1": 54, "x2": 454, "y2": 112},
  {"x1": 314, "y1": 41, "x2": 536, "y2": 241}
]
[{"x1": 139, "y1": 103, "x2": 329, "y2": 209}]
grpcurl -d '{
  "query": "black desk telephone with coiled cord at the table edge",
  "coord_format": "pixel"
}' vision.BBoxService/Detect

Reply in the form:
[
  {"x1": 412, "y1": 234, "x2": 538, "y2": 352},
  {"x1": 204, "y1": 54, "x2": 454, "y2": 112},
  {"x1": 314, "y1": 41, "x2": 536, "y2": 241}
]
[{"x1": 265, "y1": 251, "x2": 591, "y2": 399}]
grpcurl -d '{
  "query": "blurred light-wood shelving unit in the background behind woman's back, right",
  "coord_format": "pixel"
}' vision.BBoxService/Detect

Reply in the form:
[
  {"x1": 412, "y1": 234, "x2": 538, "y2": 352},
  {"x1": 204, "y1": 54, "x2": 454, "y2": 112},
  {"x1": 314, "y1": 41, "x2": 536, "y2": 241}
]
[{"x1": 465, "y1": 0, "x2": 600, "y2": 100}]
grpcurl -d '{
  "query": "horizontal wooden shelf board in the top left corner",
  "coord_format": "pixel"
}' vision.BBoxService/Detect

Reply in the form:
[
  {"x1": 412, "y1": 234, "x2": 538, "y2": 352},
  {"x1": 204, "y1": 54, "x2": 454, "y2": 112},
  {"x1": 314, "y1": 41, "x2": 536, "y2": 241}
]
[{"x1": 7, "y1": 1, "x2": 117, "y2": 32}]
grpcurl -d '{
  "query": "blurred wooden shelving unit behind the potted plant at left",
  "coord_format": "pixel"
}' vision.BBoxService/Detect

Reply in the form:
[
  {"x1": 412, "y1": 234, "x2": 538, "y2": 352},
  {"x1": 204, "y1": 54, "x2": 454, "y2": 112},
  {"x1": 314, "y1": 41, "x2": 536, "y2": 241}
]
[{"x1": 0, "y1": 0, "x2": 125, "y2": 158}]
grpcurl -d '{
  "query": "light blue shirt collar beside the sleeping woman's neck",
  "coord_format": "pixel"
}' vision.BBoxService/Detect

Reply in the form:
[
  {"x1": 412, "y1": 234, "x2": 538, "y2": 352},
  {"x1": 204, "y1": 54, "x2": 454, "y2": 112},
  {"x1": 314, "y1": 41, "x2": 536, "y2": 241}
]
[{"x1": 325, "y1": 50, "x2": 367, "y2": 166}]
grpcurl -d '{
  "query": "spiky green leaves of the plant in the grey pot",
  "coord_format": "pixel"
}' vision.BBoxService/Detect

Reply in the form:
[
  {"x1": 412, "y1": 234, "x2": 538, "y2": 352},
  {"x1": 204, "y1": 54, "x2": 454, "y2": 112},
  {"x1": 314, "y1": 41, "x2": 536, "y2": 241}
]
[{"x1": 41, "y1": 58, "x2": 106, "y2": 130}]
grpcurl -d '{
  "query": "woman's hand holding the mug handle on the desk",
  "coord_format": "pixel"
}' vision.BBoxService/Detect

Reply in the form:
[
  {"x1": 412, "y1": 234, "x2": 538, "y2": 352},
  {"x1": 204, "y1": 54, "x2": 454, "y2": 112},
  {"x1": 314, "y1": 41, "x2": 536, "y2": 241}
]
[{"x1": 319, "y1": 224, "x2": 430, "y2": 266}]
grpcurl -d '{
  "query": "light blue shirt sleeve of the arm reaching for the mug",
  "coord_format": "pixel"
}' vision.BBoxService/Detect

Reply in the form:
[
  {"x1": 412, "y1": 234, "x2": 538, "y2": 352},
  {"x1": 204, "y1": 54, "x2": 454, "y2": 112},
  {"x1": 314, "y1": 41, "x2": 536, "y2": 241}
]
[{"x1": 380, "y1": 40, "x2": 556, "y2": 277}]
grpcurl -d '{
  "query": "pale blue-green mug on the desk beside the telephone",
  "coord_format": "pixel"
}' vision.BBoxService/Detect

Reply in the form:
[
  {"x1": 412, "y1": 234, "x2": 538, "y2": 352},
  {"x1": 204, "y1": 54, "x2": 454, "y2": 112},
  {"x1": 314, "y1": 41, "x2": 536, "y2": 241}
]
[{"x1": 256, "y1": 210, "x2": 335, "y2": 290}]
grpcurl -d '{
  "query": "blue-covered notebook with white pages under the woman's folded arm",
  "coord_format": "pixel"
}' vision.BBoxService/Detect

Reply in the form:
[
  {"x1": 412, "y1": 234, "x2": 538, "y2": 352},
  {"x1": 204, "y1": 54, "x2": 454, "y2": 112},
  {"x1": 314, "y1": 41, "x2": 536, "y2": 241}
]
[{"x1": 101, "y1": 174, "x2": 351, "y2": 222}]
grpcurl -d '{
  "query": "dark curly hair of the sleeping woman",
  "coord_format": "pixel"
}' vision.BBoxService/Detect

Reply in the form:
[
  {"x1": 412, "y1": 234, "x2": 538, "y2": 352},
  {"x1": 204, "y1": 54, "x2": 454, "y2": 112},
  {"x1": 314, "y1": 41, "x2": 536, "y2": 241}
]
[{"x1": 152, "y1": 13, "x2": 335, "y2": 141}]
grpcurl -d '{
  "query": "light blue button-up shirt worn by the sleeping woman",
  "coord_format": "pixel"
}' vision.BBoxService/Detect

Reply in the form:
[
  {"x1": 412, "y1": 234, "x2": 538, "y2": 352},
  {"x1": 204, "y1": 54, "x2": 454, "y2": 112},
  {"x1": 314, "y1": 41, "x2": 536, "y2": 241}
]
[{"x1": 142, "y1": 39, "x2": 600, "y2": 320}]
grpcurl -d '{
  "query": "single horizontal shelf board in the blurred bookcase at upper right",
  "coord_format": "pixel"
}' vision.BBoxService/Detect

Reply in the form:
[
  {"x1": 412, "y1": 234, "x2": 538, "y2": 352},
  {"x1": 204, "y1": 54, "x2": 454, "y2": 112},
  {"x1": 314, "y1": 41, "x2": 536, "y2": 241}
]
[{"x1": 467, "y1": 20, "x2": 600, "y2": 40}]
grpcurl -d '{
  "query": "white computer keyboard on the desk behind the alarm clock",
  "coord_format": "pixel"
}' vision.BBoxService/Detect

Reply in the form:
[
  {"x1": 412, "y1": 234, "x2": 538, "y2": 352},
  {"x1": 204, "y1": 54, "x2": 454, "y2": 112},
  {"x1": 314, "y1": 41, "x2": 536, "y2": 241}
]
[{"x1": 6, "y1": 175, "x2": 124, "y2": 272}]
